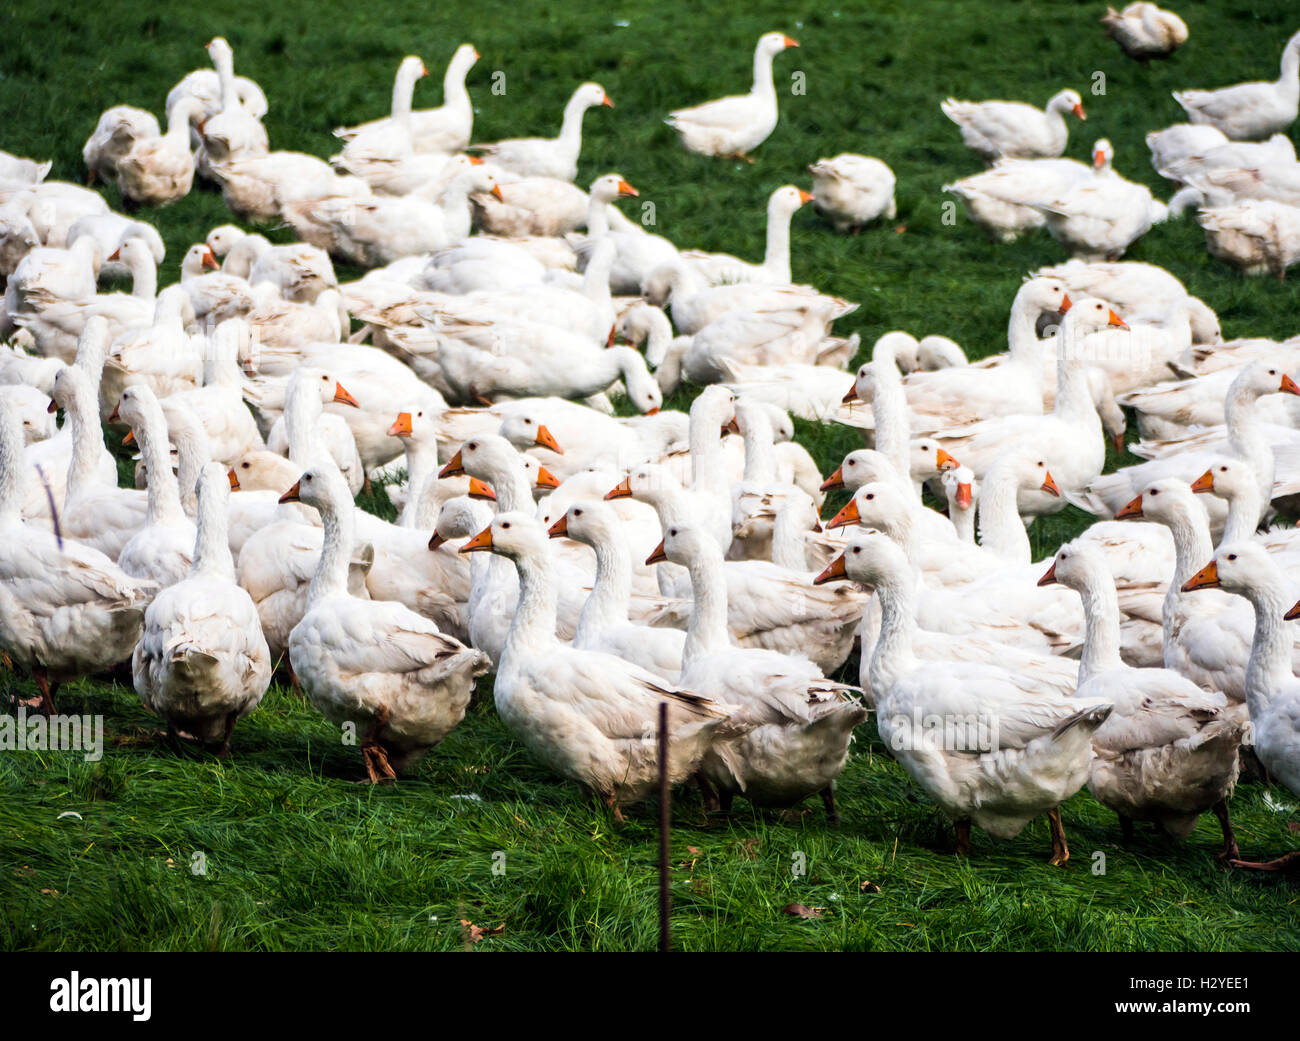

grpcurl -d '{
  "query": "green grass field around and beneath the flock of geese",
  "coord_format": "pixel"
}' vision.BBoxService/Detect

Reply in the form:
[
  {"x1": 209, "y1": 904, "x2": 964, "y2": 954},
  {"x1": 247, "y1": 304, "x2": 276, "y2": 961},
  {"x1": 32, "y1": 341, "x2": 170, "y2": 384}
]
[{"x1": 0, "y1": 0, "x2": 1300, "y2": 950}]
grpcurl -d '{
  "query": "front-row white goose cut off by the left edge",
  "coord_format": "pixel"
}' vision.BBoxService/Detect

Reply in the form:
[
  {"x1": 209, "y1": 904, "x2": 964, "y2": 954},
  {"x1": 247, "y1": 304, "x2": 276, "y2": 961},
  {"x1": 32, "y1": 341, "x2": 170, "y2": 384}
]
[{"x1": 0, "y1": 391, "x2": 153, "y2": 716}]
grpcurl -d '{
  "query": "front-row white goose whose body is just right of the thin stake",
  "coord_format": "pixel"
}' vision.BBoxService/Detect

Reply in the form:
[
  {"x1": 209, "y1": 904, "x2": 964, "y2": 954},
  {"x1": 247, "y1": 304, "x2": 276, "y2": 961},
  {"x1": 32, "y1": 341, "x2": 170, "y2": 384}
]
[{"x1": 646, "y1": 525, "x2": 867, "y2": 824}]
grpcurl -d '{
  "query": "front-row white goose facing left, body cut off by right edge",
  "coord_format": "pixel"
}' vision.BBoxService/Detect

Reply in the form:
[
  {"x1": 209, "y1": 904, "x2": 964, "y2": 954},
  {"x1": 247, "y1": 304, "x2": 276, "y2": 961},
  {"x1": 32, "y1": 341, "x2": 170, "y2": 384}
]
[{"x1": 1183, "y1": 542, "x2": 1300, "y2": 871}]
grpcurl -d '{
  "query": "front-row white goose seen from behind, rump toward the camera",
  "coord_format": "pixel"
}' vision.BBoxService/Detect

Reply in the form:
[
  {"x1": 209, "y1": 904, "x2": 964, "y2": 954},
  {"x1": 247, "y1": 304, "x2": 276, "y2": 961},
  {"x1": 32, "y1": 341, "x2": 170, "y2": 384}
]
[{"x1": 131, "y1": 463, "x2": 270, "y2": 756}]
